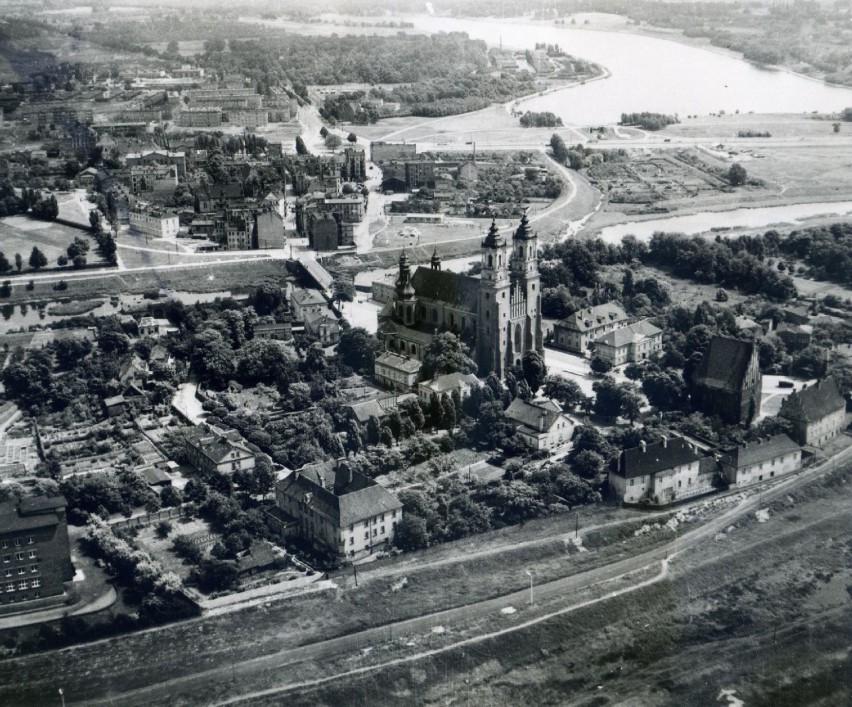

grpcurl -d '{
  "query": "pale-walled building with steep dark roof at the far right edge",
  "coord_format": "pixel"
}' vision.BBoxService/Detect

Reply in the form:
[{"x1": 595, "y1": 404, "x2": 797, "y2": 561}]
[{"x1": 778, "y1": 376, "x2": 846, "y2": 447}]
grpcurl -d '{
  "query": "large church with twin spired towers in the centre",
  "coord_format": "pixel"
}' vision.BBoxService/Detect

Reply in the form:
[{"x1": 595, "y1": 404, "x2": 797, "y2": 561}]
[{"x1": 378, "y1": 214, "x2": 544, "y2": 379}]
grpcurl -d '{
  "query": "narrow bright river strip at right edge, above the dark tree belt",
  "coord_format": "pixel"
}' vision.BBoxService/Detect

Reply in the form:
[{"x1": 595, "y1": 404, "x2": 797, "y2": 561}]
[{"x1": 599, "y1": 201, "x2": 852, "y2": 243}]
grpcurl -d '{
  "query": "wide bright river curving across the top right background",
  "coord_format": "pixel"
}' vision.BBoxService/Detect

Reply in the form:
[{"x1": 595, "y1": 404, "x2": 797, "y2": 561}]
[{"x1": 405, "y1": 16, "x2": 852, "y2": 125}]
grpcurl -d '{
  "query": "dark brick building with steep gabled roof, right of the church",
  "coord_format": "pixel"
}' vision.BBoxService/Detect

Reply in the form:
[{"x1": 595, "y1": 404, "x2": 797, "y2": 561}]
[{"x1": 691, "y1": 336, "x2": 762, "y2": 425}]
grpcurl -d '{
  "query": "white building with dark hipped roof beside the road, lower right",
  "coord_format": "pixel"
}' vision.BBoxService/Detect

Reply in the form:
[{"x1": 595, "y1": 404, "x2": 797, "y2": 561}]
[{"x1": 609, "y1": 437, "x2": 718, "y2": 506}]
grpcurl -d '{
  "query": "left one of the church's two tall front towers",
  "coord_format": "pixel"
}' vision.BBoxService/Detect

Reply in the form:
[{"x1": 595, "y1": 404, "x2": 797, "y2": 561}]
[{"x1": 476, "y1": 221, "x2": 512, "y2": 378}]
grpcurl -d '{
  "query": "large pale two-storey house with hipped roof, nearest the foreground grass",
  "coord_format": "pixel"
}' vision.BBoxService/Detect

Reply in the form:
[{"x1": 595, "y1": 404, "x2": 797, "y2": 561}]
[{"x1": 275, "y1": 461, "x2": 402, "y2": 559}]
